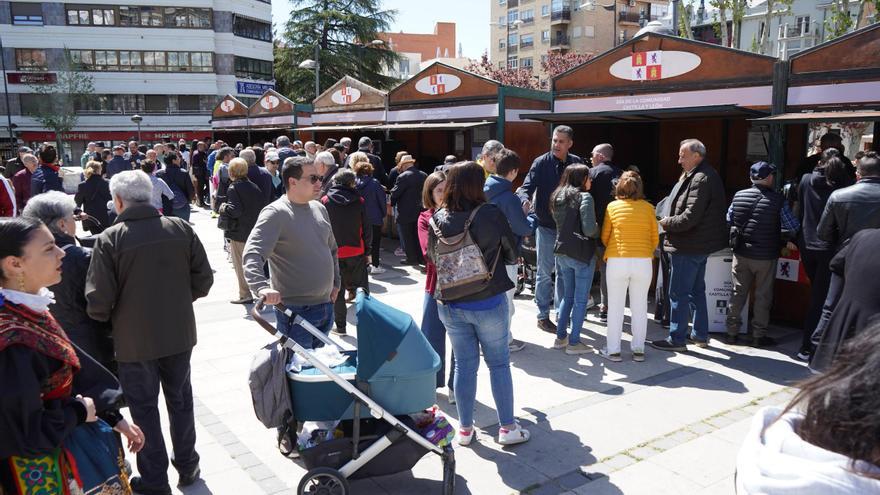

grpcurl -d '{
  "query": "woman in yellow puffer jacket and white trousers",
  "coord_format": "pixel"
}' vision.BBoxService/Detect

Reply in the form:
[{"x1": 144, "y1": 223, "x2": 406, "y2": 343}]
[{"x1": 599, "y1": 171, "x2": 659, "y2": 362}]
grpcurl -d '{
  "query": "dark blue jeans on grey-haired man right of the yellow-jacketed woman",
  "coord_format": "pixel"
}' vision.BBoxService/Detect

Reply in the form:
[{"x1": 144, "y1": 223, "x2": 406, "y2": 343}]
[{"x1": 667, "y1": 253, "x2": 709, "y2": 345}]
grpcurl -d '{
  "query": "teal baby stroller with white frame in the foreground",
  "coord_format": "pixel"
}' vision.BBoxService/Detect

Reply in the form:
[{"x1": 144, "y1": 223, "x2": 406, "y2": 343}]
[{"x1": 251, "y1": 290, "x2": 455, "y2": 495}]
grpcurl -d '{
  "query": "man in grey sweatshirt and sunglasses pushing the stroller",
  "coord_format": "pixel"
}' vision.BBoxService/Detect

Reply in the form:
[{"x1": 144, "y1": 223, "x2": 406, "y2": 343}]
[{"x1": 242, "y1": 156, "x2": 340, "y2": 349}]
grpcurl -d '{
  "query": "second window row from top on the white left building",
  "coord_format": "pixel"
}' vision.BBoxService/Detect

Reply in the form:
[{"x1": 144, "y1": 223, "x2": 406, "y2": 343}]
[{"x1": 70, "y1": 50, "x2": 214, "y2": 72}]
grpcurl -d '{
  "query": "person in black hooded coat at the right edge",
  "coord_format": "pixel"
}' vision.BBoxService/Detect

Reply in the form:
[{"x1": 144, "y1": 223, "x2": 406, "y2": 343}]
[{"x1": 810, "y1": 229, "x2": 880, "y2": 371}]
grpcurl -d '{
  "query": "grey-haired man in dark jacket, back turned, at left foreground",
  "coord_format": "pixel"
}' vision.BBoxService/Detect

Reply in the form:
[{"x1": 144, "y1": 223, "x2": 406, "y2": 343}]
[{"x1": 85, "y1": 171, "x2": 214, "y2": 494}]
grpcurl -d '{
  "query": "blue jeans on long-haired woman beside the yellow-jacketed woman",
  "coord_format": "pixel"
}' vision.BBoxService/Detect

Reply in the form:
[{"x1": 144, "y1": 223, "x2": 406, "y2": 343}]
[{"x1": 556, "y1": 255, "x2": 596, "y2": 345}]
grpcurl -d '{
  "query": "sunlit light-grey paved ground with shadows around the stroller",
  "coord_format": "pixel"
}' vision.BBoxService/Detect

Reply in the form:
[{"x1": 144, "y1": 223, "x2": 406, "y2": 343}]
[{"x1": 125, "y1": 210, "x2": 808, "y2": 495}]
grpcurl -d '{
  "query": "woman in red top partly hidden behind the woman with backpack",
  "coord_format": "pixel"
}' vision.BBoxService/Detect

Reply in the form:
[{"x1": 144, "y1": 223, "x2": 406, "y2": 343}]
[{"x1": 418, "y1": 172, "x2": 455, "y2": 404}]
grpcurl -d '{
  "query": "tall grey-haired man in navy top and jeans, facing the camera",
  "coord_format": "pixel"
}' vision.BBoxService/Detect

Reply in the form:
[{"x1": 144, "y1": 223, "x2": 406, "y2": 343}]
[{"x1": 516, "y1": 125, "x2": 583, "y2": 334}]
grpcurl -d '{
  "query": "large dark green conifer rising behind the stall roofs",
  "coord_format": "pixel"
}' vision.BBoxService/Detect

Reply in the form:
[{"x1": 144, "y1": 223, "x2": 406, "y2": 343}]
[{"x1": 274, "y1": 0, "x2": 401, "y2": 101}]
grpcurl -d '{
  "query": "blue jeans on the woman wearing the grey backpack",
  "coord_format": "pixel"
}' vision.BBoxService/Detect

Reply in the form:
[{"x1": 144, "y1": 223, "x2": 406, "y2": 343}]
[{"x1": 437, "y1": 297, "x2": 513, "y2": 428}]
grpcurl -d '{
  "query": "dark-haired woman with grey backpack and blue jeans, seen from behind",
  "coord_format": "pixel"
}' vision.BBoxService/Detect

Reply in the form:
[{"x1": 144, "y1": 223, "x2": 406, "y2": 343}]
[{"x1": 428, "y1": 162, "x2": 529, "y2": 445}]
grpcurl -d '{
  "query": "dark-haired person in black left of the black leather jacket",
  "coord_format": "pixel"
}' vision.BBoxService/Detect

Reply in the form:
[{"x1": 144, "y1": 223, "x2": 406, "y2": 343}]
[{"x1": 797, "y1": 148, "x2": 852, "y2": 361}]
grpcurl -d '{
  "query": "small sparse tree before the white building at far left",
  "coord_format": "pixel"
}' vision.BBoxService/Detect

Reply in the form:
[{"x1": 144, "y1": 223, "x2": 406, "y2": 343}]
[{"x1": 30, "y1": 49, "x2": 95, "y2": 167}]
